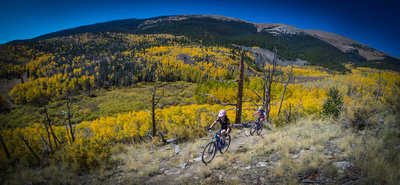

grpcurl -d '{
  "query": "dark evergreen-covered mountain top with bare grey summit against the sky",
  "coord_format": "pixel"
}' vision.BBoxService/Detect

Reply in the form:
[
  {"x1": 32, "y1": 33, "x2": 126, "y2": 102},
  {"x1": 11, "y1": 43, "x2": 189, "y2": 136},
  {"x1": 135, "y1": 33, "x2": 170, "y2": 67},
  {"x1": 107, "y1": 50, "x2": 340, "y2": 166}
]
[{"x1": 6, "y1": 15, "x2": 400, "y2": 71}]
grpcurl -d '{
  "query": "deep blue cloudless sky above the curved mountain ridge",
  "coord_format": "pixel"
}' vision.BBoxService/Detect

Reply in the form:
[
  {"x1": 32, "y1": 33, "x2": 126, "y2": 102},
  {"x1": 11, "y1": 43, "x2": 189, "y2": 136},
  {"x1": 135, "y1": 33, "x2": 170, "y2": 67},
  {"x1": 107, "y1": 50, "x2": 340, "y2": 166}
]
[{"x1": 0, "y1": 0, "x2": 400, "y2": 57}]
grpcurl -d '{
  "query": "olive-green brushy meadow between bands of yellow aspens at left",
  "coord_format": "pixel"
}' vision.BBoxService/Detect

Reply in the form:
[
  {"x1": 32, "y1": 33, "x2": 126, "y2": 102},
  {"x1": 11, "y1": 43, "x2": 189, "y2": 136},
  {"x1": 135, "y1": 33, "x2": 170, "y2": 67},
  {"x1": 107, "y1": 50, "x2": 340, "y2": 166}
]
[{"x1": 0, "y1": 82, "x2": 196, "y2": 128}]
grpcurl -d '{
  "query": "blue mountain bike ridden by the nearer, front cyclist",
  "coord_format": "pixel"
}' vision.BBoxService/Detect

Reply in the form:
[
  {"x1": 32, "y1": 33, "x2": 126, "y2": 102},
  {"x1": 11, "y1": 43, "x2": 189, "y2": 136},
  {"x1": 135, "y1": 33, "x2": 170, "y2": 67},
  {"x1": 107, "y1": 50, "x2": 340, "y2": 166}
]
[{"x1": 201, "y1": 130, "x2": 231, "y2": 164}]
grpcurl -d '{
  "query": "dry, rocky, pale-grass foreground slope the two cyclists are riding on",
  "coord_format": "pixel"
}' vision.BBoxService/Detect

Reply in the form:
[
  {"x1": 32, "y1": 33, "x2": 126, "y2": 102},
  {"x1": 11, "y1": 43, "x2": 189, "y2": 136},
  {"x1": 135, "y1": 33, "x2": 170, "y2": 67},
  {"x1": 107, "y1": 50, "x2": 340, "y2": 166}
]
[{"x1": 9, "y1": 115, "x2": 400, "y2": 184}]
